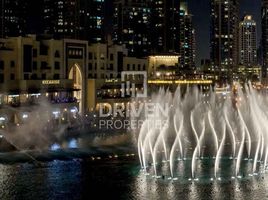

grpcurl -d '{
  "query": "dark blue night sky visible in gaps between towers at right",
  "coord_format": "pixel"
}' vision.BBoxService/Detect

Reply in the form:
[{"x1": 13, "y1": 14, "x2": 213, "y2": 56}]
[{"x1": 189, "y1": 0, "x2": 261, "y2": 66}]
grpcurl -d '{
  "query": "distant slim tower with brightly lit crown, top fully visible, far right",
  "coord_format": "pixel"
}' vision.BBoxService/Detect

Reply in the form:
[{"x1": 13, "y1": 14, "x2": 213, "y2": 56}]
[{"x1": 239, "y1": 15, "x2": 257, "y2": 66}]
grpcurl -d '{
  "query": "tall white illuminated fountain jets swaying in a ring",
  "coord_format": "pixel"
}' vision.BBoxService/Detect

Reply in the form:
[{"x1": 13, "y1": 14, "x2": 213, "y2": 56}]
[{"x1": 138, "y1": 84, "x2": 268, "y2": 181}]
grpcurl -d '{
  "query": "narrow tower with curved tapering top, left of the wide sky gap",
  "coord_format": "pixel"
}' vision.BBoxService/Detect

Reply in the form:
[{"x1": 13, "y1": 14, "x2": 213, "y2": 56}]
[{"x1": 179, "y1": 2, "x2": 195, "y2": 72}]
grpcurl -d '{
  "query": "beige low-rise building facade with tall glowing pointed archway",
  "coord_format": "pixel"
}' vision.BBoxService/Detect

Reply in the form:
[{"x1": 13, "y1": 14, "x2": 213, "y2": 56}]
[{"x1": 0, "y1": 35, "x2": 147, "y2": 113}]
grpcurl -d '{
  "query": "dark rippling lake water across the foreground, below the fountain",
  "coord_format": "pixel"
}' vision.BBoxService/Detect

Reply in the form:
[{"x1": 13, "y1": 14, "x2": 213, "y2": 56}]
[{"x1": 0, "y1": 159, "x2": 268, "y2": 200}]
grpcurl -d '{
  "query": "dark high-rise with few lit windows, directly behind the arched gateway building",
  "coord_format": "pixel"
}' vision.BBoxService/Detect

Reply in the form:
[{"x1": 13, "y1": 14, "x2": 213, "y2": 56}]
[{"x1": 44, "y1": 0, "x2": 104, "y2": 42}]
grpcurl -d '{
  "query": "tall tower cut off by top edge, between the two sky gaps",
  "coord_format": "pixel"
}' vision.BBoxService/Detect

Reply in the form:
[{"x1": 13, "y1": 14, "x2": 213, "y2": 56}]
[{"x1": 210, "y1": 0, "x2": 239, "y2": 80}]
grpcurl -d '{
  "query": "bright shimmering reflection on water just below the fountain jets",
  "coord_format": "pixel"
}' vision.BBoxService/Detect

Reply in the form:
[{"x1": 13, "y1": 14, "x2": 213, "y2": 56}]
[{"x1": 133, "y1": 168, "x2": 268, "y2": 200}]
